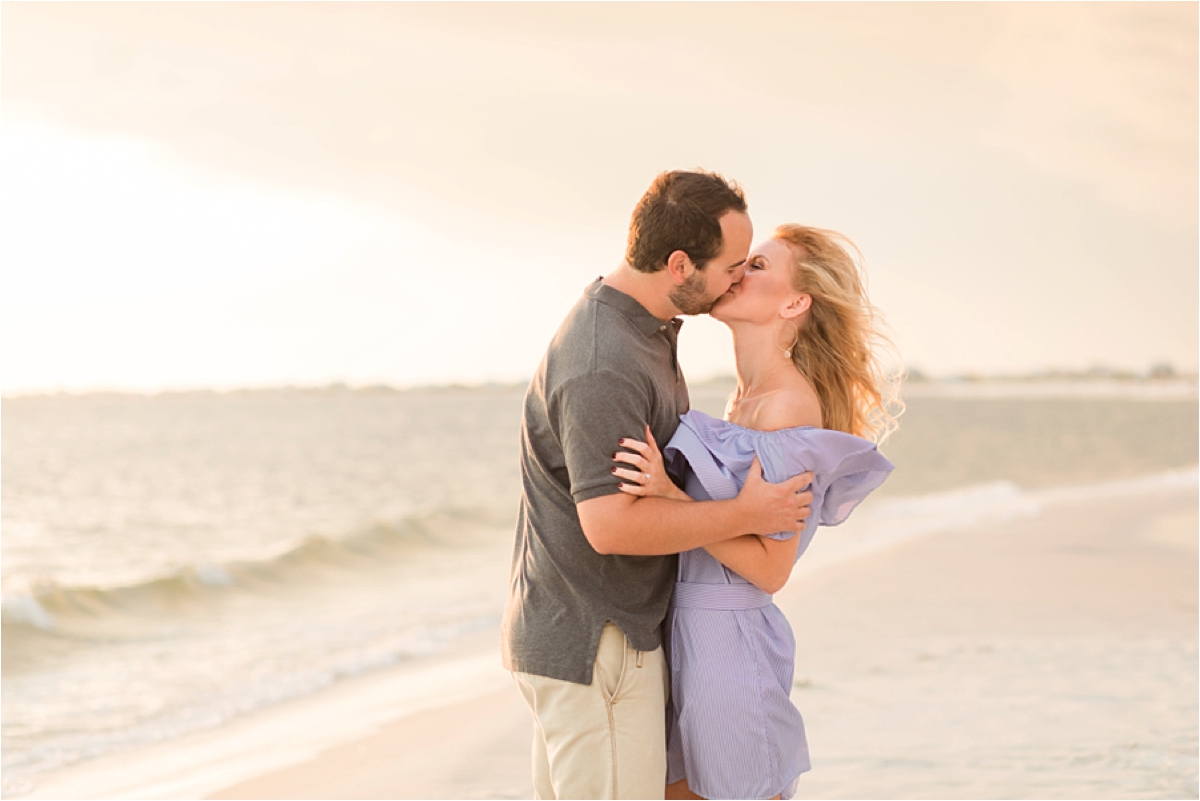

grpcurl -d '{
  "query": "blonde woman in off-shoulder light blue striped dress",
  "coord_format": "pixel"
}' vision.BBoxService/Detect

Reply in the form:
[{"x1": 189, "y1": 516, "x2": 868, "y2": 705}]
[{"x1": 616, "y1": 225, "x2": 899, "y2": 799}]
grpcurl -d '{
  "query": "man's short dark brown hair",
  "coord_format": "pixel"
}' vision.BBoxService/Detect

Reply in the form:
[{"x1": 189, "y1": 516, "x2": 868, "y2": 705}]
[{"x1": 625, "y1": 170, "x2": 746, "y2": 272}]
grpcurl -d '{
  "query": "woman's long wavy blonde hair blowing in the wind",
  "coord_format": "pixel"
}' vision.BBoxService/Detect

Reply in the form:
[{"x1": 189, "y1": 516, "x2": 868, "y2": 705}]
[{"x1": 774, "y1": 225, "x2": 904, "y2": 442}]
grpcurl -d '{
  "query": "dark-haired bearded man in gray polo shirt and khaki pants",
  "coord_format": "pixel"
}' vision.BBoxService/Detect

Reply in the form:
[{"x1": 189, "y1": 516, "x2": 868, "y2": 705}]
[{"x1": 502, "y1": 171, "x2": 811, "y2": 799}]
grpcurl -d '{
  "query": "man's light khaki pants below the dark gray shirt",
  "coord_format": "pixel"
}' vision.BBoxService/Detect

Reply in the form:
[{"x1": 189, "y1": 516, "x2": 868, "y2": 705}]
[{"x1": 512, "y1": 624, "x2": 670, "y2": 799}]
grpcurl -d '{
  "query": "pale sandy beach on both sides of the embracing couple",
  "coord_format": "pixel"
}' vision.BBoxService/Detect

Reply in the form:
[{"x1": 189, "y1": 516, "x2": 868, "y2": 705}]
[{"x1": 29, "y1": 472, "x2": 1198, "y2": 799}]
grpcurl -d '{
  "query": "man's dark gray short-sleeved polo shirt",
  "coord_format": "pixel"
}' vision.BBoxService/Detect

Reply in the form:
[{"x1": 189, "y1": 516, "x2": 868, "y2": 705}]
[{"x1": 502, "y1": 279, "x2": 689, "y2": 685}]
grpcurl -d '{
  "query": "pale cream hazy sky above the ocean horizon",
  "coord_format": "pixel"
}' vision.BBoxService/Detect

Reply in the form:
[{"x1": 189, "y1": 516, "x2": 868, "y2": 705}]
[{"x1": 0, "y1": 2, "x2": 1200, "y2": 393}]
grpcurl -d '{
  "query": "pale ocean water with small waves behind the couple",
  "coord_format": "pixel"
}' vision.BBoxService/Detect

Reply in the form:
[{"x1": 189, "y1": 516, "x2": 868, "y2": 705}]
[{"x1": 0, "y1": 383, "x2": 1198, "y2": 797}]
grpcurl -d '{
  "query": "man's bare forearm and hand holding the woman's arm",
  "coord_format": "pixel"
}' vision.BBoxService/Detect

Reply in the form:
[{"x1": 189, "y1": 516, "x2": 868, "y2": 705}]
[{"x1": 576, "y1": 458, "x2": 812, "y2": 556}]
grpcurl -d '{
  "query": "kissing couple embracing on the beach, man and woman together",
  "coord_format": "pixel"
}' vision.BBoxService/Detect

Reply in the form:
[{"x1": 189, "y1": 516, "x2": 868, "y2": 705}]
[{"x1": 502, "y1": 171, "x2": 895, "y2": 799}]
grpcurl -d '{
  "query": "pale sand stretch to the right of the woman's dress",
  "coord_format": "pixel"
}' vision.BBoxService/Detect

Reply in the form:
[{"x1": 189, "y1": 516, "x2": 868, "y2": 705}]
[{"x1": 784, "y1": 479, "x2": 1198, "y2": 799}]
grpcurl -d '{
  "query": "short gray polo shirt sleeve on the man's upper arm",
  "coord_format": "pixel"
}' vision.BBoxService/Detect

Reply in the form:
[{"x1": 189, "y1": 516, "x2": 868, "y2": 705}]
[{"x1": 554, "y1": 371, "x2": 653, "y2": 504}]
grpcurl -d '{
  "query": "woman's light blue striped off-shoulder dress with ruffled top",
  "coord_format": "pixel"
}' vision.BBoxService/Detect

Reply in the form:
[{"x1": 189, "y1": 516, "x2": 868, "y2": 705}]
[{"x1": 664, "y1": 411, "x2": 892, "y2": 799}]
